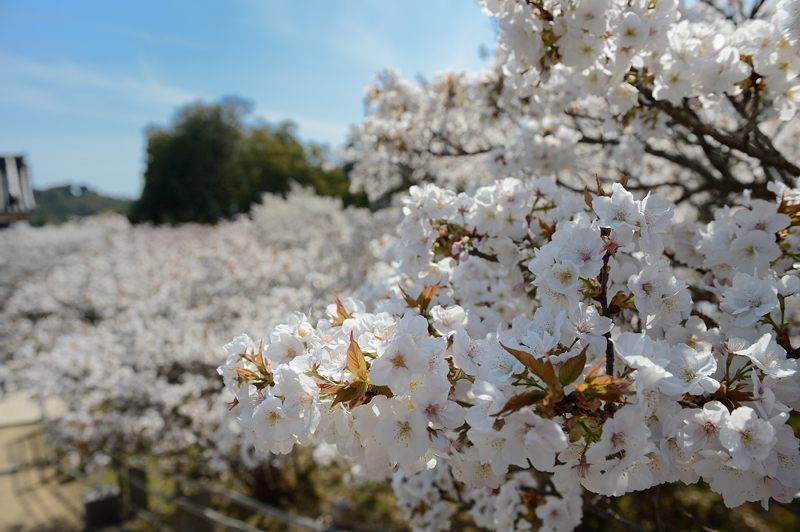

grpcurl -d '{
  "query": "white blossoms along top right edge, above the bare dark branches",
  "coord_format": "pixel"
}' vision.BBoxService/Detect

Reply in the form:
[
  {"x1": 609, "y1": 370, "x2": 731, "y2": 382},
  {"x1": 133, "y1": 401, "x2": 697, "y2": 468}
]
[{"x1": 483, "y1": 0, "x2": 800, "y2": 116}]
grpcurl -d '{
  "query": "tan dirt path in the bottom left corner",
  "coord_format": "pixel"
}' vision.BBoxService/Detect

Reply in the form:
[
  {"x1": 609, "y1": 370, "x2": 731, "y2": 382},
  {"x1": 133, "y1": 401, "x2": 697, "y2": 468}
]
[{"x1": 0, "y1": 395, "x2": 83, "y2": 532}]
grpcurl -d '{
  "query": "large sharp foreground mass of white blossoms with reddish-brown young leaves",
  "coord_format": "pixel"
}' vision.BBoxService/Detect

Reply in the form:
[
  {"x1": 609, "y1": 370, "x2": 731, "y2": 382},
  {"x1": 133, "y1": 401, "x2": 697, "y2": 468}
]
[{"x1": 219, "y1": 178, "x2": 800, "y2": 530}]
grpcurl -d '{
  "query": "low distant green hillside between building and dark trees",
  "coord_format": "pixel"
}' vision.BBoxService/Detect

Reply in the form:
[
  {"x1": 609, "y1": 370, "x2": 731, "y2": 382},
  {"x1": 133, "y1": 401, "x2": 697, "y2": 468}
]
[{"x1": 30, "y1": 185, "x2": 131, "y2": 225}]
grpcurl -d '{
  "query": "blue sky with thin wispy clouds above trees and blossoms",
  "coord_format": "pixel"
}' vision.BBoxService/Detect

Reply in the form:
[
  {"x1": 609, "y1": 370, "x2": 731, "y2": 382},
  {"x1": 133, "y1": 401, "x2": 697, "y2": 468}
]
[{"x1": 0, "y1": 0, "x2": 494, "y2": 197}]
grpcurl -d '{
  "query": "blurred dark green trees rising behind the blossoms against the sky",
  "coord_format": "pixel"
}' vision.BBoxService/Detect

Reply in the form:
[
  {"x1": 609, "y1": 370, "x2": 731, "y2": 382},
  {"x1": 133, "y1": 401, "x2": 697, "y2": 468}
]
[{"x1": 130, "y1": 99, "x2": 363, "y2": 223}]
